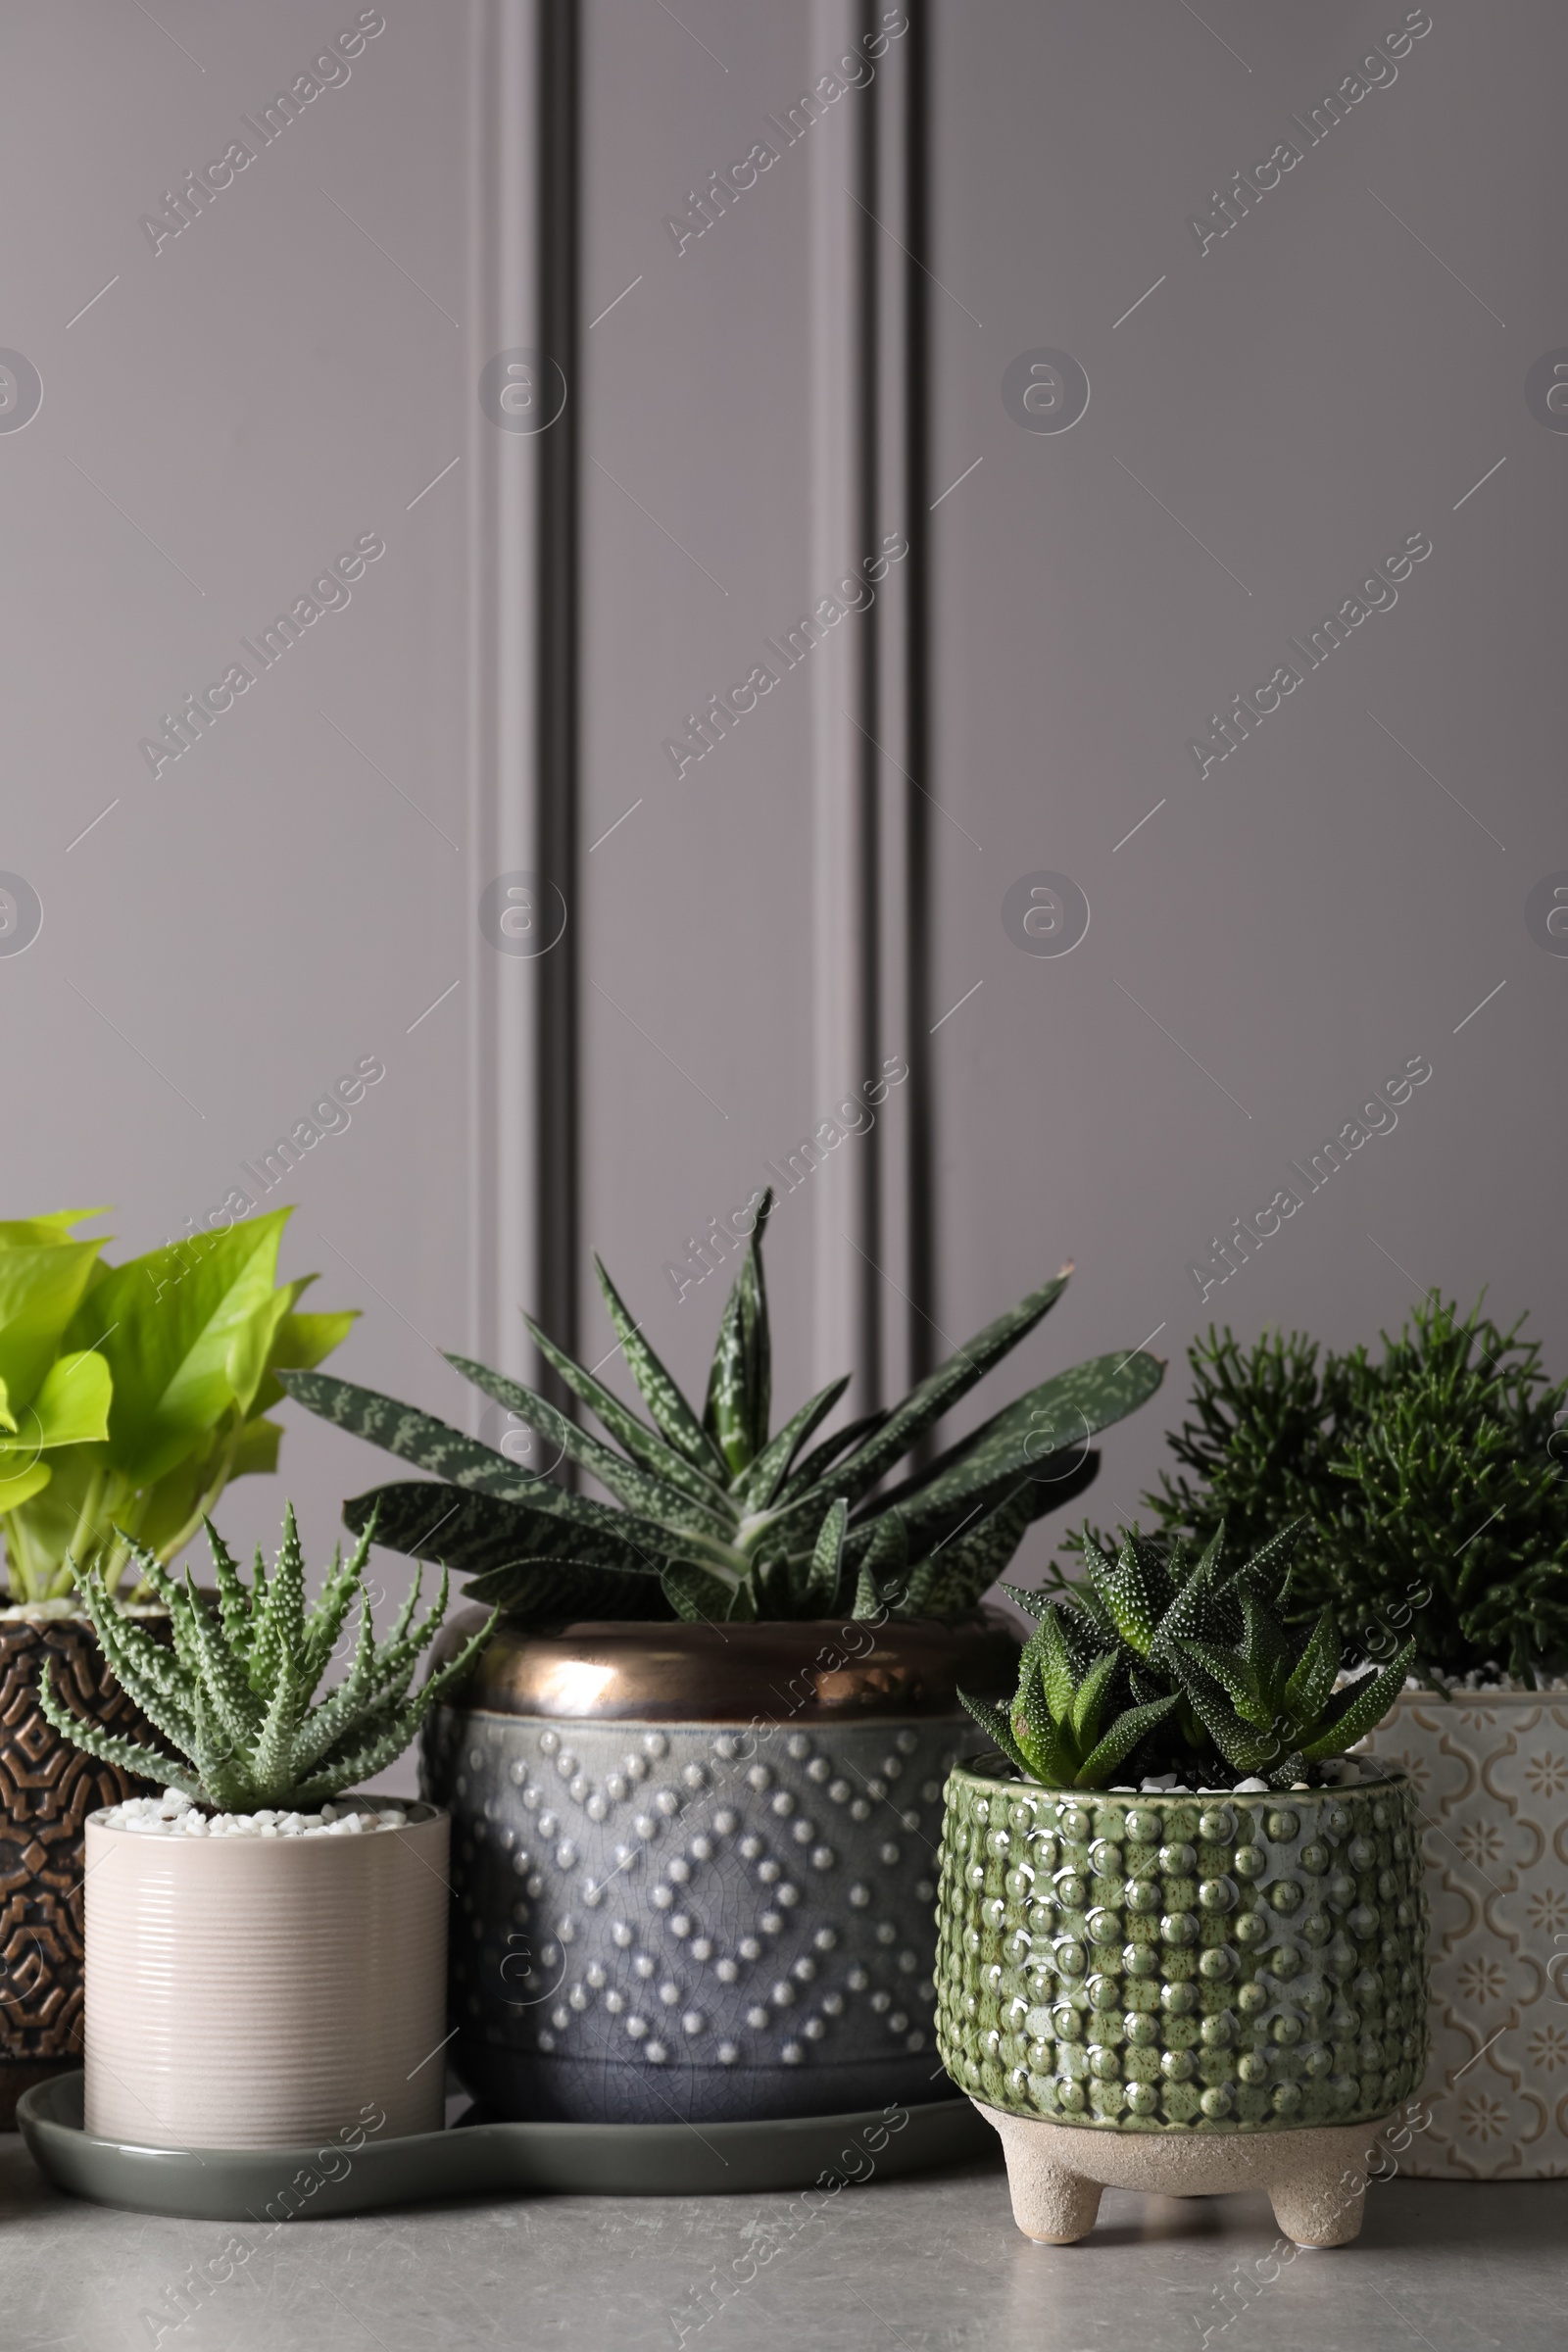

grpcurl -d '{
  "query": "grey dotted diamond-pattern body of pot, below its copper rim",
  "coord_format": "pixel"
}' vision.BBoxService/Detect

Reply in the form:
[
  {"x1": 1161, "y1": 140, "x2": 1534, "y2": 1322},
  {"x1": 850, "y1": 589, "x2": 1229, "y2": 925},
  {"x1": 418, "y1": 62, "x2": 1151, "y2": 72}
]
[{"x1": 420, "y1": 1707, "x2": 980, "y2": 2122}]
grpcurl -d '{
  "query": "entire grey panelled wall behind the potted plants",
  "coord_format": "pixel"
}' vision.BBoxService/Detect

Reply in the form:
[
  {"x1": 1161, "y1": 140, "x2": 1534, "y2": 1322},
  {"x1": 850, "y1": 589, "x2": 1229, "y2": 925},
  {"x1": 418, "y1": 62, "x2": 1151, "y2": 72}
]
[{"x1": 0, "y1": 0, "x2": 1568, "y2": 1637}]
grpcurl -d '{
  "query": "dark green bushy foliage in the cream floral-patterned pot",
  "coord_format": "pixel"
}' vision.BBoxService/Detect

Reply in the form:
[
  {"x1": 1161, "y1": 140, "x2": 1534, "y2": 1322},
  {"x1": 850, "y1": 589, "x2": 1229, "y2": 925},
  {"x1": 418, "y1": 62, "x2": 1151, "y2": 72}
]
[{"x1": 1123, "y1": 1294, "x2": 1568, "y2": 1689}]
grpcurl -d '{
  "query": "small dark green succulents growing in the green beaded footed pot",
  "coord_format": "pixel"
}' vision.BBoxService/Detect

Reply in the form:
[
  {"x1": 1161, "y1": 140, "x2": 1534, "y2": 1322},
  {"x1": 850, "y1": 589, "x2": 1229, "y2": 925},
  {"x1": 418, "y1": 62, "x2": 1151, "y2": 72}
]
[{"x1": 959, "y1": 1522, "x2": 1413, "y2": 1789}]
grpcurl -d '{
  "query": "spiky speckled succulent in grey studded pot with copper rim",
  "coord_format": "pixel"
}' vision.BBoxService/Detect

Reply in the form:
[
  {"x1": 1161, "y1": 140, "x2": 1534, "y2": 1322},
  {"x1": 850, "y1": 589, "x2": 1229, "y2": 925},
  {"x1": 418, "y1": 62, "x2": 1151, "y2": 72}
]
[{"x1": 284, "y1": 1200, "x2": 1163, "y2": 2122}]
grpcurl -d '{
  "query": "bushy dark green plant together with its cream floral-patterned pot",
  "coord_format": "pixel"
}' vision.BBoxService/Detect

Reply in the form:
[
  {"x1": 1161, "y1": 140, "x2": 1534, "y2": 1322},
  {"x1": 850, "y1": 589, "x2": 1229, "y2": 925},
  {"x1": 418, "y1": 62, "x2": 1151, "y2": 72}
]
[{"x1": 1128, "y1": 1294, "x2": 1568, "y2": 2180}]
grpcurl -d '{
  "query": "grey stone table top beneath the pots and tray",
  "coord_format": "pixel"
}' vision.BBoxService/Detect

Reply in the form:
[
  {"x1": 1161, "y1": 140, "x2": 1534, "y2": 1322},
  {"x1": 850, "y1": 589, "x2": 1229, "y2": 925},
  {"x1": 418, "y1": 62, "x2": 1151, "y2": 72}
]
[{"x1": 0, "y1": 2135, "x2": 1568, "y2": 2352}]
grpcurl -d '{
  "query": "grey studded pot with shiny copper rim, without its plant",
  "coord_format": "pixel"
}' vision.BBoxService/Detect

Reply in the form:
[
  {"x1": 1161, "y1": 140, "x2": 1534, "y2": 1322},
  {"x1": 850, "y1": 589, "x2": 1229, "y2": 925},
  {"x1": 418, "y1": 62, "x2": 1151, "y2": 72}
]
[{"x1": 420, "y1": 1611, "x2": 1018, "y2": 2124}]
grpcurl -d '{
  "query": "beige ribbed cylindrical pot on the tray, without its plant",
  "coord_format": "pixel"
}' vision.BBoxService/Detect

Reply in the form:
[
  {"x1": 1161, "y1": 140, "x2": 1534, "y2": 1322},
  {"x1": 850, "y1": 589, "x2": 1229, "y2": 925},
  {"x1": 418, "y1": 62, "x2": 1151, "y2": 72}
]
[{"x1": 84, "y1": 1804, "x2": 447, "y2": 2147}]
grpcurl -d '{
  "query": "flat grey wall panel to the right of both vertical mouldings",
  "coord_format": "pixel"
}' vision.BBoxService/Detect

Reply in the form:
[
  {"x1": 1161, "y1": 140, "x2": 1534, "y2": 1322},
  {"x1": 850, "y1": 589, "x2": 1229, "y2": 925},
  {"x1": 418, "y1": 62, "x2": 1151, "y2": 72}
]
[{"x1": 933, "y1": 0, "x2": 1568, "y2": 1545}]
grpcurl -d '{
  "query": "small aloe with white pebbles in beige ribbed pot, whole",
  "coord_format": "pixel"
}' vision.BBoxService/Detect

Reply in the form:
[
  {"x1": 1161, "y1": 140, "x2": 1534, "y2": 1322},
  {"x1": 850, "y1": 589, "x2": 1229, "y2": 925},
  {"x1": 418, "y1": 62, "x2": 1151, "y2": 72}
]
[{"x1": 37, "y1": 1505, "x2": 489, "y2": 2147}]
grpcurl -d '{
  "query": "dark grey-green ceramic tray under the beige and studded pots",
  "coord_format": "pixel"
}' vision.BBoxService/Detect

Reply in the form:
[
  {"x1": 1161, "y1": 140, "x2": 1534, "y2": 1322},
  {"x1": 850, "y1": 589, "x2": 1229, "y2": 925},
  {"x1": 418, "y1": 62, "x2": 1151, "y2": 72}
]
[{"x1": 17, "y1": 2075, "x2": 997, "y2": 2228}]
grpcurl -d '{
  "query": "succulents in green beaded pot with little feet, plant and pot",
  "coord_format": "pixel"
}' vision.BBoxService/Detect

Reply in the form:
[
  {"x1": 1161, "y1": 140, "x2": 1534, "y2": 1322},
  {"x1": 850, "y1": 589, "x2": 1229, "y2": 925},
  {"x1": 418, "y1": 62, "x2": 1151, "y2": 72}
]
[{"x1": 938, "y1": 1529, "x2": 1427, "y2": 2246}]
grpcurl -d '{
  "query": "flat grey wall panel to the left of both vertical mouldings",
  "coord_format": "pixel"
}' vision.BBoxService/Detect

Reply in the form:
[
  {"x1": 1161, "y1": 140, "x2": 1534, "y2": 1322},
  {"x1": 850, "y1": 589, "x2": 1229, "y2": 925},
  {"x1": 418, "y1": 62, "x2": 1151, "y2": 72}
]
[{"x1": 0, "y1": 0, "x2": 477, "y2": 1574}]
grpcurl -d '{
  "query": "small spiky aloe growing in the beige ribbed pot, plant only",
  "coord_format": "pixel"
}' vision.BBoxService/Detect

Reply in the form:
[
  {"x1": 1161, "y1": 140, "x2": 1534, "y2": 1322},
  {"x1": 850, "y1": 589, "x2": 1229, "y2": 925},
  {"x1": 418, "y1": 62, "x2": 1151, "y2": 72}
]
[{"x1": 37, "y1": 1503, "x2": 494, "y2": 1813}]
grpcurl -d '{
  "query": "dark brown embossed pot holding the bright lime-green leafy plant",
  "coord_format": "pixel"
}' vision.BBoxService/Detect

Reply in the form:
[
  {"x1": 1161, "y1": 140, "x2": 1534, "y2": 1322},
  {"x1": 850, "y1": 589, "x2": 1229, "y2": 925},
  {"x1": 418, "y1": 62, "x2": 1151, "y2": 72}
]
[{"x1": 0, "y1": 1616, "x2": 167, "y2": 2131}]
